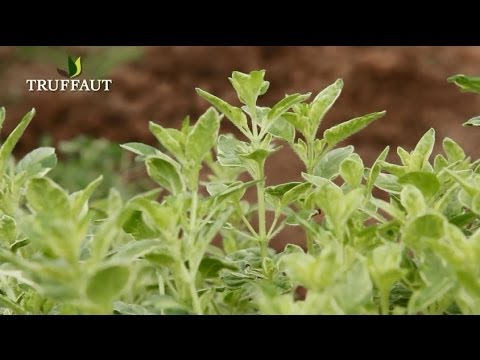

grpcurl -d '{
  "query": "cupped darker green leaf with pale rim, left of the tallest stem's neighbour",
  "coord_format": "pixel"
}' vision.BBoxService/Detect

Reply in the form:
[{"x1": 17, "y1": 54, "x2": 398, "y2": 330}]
[{"x1": 145, "y1": 156, "x2": 185, "y2": 194}]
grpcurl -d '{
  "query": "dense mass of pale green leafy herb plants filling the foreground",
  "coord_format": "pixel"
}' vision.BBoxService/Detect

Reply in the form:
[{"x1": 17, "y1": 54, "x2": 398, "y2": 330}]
[{"x1": 0, "y1": 71, "x2": 480, "y2": 314}]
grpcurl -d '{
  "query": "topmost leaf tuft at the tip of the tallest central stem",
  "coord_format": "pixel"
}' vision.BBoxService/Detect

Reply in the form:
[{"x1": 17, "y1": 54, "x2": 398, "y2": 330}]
[{"x1": 228, "y1": 70, "x2": 269, "y2": 108}]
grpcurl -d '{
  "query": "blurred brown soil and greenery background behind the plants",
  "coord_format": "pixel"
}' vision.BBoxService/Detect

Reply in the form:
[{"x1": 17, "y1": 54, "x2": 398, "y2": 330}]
[{"x1": 0, "y1": 46, "x2": 480, "y2": 248}]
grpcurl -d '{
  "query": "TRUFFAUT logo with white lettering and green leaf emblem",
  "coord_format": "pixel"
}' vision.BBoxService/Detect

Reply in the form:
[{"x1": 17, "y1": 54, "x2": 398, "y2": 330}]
[{"x1": 26, "y1": 56, "x2": 112, "y2": 92}]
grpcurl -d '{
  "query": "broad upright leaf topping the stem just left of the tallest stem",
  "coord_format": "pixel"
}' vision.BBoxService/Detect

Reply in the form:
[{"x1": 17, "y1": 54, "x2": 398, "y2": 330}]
[{"x1": 186, "y1": 108, "x2": 220, "y2": 165}]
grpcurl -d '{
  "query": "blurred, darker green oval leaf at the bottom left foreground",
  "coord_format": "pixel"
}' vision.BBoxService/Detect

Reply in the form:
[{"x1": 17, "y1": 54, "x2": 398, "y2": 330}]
[{"x1": 87, "y1": 265, "x2": 130, "y2": 305}]
